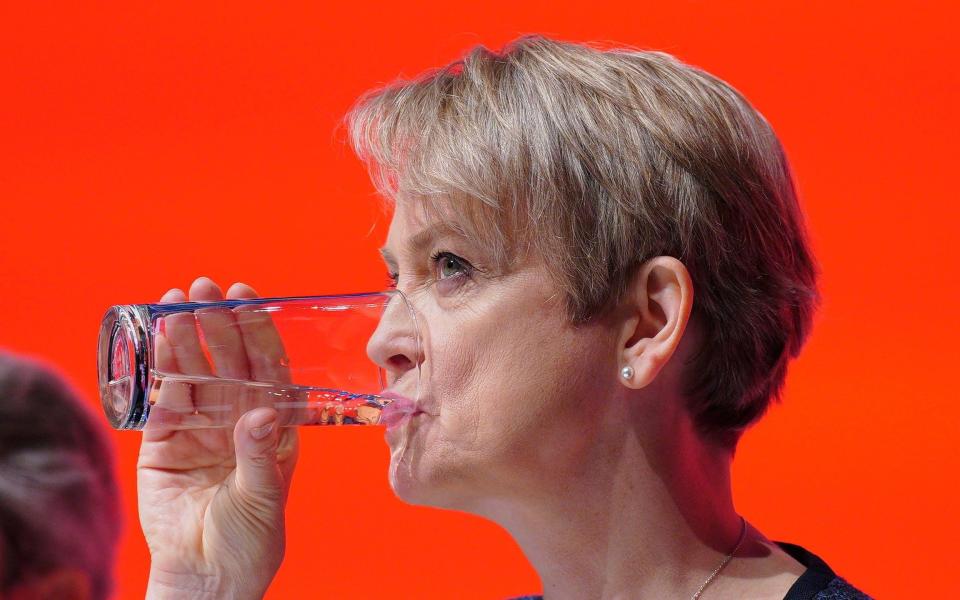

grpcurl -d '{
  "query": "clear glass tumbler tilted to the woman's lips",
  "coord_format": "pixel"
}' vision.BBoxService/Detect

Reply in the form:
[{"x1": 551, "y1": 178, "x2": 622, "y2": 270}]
[{"x1": 97, "y1": 290, "x2": 420, "y2": 429}]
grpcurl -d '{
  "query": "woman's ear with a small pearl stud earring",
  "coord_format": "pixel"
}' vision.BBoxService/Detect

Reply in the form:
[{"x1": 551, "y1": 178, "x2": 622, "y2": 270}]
[{"x1": 618, "y1": 256, "x2": 693, "y2": 389}]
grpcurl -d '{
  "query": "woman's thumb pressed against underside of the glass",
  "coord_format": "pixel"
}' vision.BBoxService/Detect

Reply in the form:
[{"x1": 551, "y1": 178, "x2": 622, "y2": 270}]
[{"x1": 233, "y1": 408, "x2": 283, "y2": 503}]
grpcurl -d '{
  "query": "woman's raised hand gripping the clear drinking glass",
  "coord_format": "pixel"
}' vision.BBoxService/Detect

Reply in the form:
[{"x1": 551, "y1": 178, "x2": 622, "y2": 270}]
[{"x1": 137, "y1": 277, "x2": 297, "y2": 599}]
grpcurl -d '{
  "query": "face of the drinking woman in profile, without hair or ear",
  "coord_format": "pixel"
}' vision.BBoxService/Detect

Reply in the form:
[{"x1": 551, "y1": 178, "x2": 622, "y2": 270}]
[{"x1": 368, "y1": 201, "x2": 622, "y2": 514}]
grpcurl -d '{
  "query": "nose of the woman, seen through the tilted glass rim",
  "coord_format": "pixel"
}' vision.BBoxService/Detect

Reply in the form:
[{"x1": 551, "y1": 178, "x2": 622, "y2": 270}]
[{"x1": 367, "y1": 290, "x2": 420, "y2": 392}]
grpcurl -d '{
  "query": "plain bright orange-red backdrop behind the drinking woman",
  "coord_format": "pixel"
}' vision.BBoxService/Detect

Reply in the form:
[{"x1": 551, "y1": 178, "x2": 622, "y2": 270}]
[{"x1": 0, "y1": 0, "x2": 960, "y2": 598}]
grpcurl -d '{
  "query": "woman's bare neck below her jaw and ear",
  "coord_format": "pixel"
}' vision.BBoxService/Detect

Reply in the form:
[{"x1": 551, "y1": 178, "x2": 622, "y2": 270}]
[{"x1": 480, "y1": 400, "x2": 741, "y2": 599}]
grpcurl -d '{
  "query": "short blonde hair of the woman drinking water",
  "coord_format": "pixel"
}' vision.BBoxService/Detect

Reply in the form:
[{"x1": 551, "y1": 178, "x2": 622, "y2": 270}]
[{"x1": 347, "y1": 36, "x2": 819, "y2": 447}]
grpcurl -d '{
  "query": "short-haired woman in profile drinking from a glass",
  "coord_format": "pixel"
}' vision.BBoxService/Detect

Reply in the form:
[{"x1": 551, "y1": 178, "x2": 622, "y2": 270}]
[{"x1": 140, "y1": 37, "x2": 865, "y2": 599}]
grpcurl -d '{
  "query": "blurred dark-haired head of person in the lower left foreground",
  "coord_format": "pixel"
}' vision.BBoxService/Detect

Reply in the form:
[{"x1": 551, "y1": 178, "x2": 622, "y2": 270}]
[{"x1": 0, "y1": 351, "x2": 120, "y2": 600}]
